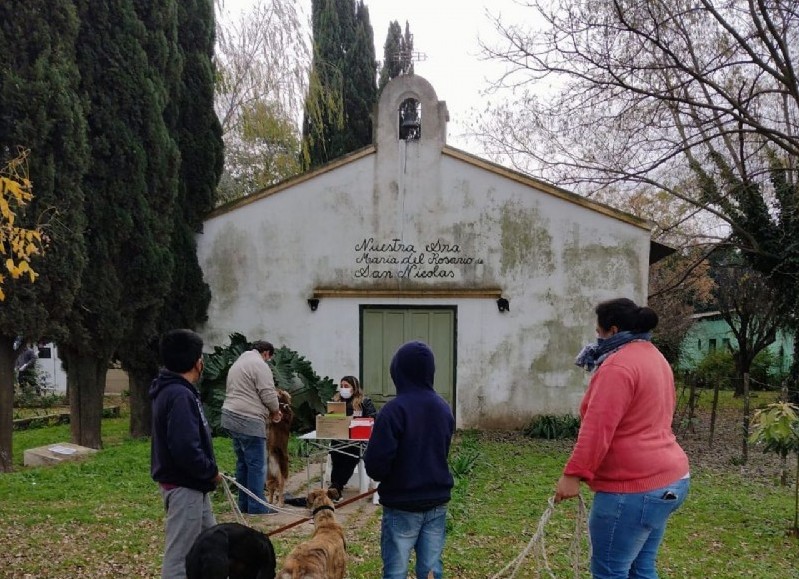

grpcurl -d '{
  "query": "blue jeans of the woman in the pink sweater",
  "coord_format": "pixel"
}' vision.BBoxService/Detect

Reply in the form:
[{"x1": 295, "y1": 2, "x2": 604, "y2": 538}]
[{"x1": 588, "y1": 478, "x2": 690, "y2": 579}]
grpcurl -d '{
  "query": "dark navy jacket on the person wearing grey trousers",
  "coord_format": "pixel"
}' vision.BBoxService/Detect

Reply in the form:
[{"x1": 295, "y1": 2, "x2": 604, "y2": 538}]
[{"x1": 150, "y1": 370, "x2": 219, "y2": 492}]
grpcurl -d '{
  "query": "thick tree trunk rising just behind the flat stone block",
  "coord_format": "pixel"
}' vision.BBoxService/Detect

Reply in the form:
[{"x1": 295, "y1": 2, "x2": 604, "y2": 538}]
[{"x1": 66, "y1": 353, "x2": 108, "y2": 449}]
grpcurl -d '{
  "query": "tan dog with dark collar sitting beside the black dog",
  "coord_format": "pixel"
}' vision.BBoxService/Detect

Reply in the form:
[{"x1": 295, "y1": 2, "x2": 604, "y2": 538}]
[{"x1": 275, "y1": 489, "x2": 347, "y2": 579}]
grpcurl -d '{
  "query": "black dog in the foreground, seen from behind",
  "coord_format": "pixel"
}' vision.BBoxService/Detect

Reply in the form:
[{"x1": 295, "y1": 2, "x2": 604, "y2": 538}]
[{"x1": 186, "y1": 523, "x2": 275, "y2": 579}]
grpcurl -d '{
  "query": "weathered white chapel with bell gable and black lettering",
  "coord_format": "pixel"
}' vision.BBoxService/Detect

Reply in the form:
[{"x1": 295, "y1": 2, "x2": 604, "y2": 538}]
[{"x1": 198, "y1": 75, "x2": 662, "y2": 429}]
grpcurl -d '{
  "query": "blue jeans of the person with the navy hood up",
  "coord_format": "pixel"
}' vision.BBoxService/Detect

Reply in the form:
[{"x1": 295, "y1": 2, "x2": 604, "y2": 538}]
[{"x1": 380, "y1": 505, "x2": 447, "y2": 579}]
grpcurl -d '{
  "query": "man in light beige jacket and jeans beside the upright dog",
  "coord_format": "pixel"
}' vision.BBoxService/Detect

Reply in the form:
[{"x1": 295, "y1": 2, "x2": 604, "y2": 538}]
[{"x1": 221, "y1": 341, "x2": 282, "y2": 515}]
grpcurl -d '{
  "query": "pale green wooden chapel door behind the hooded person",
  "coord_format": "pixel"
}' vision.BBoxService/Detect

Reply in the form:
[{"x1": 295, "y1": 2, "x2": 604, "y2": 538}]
[{"x1": 361, "y1": 306, "x2": 455, "y2": 408}]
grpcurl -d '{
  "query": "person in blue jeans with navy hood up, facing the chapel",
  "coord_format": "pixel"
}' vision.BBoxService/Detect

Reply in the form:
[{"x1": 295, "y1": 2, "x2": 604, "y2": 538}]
[{"x1": 364, "y1": 342, "x2": 455, "y2": 579}]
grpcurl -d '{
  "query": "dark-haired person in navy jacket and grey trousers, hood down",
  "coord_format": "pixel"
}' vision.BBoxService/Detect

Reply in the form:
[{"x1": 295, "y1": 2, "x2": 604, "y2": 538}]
[{"x1": 150, "y1": 330, "x2": 222, "y2": 579}]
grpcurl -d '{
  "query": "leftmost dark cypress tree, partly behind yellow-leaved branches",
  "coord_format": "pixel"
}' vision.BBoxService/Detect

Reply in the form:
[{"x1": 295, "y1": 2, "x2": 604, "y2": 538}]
[{"x1": 0, "y1": 0, "x2": 88, "y2": 471}]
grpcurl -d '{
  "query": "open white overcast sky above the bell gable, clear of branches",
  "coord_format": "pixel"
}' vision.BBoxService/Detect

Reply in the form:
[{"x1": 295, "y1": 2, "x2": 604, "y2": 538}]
[{"x1": 220, "y1": 0, "x2": 532, "y2": 156}]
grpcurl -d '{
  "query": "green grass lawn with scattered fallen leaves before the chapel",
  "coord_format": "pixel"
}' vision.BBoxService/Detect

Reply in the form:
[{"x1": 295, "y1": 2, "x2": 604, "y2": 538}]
[{"x1": 0, "y1": 392, "x2": 799, "y2": 579}]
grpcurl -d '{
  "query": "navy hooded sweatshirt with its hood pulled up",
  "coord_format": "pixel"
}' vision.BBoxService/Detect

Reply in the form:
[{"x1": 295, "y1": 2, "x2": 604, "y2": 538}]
[{"x1": 364, "y1": 342, "x2": 455, "y2": 511}]
